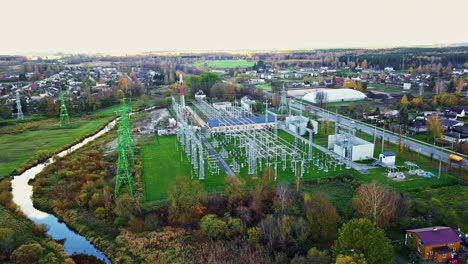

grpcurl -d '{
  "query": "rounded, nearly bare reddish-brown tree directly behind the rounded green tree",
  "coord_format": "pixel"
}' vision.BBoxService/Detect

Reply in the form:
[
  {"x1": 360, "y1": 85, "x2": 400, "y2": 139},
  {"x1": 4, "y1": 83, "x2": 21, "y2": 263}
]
[{"x1": 353, "y1": 182, "x2": 400, "y2": 226}]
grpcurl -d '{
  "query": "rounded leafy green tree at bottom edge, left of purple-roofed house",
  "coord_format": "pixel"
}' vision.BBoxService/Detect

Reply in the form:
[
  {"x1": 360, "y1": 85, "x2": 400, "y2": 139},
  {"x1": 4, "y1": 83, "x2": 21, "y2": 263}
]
[{"x1": 333, "y1": 218, "x2": 395, "y2": 264}]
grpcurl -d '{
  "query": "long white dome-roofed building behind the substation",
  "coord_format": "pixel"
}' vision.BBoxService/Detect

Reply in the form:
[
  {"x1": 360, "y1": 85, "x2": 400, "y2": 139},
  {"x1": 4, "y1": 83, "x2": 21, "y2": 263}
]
[{"x1": 302, "y1": 88, "x2": 367, "y2": 104}]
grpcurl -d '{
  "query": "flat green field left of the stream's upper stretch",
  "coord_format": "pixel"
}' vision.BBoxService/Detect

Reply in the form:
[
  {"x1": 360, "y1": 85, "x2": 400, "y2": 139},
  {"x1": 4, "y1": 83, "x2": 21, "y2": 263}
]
[{"x1": 0, "y1": 115, "x2": 111, "y2": 177}]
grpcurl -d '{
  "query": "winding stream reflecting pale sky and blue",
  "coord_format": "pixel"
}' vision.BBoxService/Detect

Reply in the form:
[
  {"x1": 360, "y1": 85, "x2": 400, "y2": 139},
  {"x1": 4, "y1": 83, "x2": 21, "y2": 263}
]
[{"x1": 11, "y1": 119, "x2": 117, "y2": 263}]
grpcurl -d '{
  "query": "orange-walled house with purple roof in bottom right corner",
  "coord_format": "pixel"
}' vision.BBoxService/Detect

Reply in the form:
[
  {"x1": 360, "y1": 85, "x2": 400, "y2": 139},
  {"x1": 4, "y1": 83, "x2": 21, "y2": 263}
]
[{"x1": 405, "y1": 226, "x2": 461, "y2": 261}]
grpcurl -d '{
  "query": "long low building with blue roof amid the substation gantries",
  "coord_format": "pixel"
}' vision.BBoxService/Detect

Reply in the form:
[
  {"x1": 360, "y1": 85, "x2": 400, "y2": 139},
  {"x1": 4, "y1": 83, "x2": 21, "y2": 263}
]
[{"x1": 207, "y1": 115, "x2": 276, "y2": 133}]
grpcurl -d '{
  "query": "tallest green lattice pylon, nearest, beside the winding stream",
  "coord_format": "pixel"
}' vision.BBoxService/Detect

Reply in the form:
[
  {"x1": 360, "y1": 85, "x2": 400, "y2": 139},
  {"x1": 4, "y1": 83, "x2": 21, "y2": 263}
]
[{"x1": 114, "y1": 98, "x2": 135, "y2": 197}]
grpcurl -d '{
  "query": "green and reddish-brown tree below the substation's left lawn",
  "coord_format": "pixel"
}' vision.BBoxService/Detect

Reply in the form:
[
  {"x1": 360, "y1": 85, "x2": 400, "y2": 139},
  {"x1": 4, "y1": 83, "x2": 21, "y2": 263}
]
[{"x1": 168, "y1": 176, "x2": 207, "y2": 225}]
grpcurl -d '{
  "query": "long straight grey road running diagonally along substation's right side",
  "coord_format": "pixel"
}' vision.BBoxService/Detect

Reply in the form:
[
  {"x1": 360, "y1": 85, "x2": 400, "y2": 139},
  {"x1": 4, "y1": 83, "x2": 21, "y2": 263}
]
[{"x1": 294, "y1": 102, "x2": 468, "y2": 168}]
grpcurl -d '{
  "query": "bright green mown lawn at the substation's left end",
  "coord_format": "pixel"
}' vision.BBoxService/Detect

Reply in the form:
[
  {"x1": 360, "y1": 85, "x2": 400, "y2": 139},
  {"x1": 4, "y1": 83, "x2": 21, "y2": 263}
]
[{"x1": 141, "y1": 136, "x2": 225, "y2": 202}]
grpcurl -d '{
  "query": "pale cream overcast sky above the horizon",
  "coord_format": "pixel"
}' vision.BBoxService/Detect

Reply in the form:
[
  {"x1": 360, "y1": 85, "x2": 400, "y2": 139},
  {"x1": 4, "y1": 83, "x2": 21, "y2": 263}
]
[{"x1": 0, "y1": 0, "x2": 468, "y2": 55}]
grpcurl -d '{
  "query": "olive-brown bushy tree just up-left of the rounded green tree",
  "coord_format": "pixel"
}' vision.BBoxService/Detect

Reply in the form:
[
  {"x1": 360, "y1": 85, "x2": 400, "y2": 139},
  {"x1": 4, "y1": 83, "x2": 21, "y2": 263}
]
[{"x1": 304, "y1": 193, "x2": 341, "y2": 243}]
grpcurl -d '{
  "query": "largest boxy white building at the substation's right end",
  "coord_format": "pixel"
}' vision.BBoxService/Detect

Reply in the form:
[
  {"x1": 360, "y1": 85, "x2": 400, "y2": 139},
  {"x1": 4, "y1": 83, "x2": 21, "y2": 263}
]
[{"x1": 328, "y1": 133, "x2": 374, "y2": 161}]
